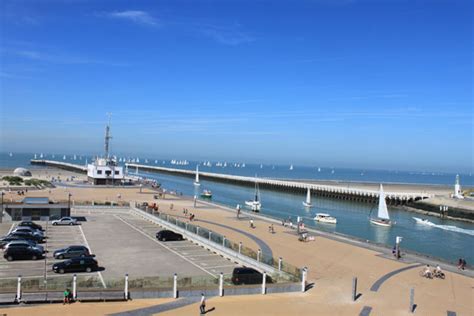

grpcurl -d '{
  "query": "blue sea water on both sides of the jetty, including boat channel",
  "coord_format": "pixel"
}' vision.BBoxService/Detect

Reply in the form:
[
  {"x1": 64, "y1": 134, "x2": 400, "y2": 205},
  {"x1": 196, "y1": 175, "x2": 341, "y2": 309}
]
[{"x1": 0, "y1": 153, "x2": 474, "y2": 264}]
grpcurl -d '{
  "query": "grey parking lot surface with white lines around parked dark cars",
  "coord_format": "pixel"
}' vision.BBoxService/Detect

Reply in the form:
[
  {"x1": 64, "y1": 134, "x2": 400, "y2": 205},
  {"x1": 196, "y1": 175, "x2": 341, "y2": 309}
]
[{"x1": 0, "y1": 208, "x2": 236, "y2": 287}]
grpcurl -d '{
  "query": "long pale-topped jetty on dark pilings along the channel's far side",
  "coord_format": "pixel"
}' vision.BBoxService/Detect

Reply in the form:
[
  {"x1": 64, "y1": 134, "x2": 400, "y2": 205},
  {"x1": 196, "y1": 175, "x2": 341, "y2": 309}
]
[{"x1": 126, "y1": 163, "x2": 433, "y2": 205}]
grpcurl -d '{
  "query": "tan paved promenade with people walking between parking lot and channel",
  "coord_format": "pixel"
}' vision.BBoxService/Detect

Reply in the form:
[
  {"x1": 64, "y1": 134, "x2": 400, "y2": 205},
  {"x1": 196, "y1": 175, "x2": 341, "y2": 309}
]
[{"x1": 0, "y1": 179, "x2": 474, "y2": 316}]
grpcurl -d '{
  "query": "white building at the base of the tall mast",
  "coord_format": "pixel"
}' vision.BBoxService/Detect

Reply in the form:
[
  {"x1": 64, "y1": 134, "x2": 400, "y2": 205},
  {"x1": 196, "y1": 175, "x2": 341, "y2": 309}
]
[{"x1": 87, "y1": 158, "x2": 124, "y2": 185}]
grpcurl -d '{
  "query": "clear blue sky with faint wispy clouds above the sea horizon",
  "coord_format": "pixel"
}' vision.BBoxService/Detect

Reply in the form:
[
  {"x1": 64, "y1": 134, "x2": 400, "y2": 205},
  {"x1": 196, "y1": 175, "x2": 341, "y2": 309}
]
[{"x1": 0, "y1": 0, "x2": 474, "y2": 172}]
